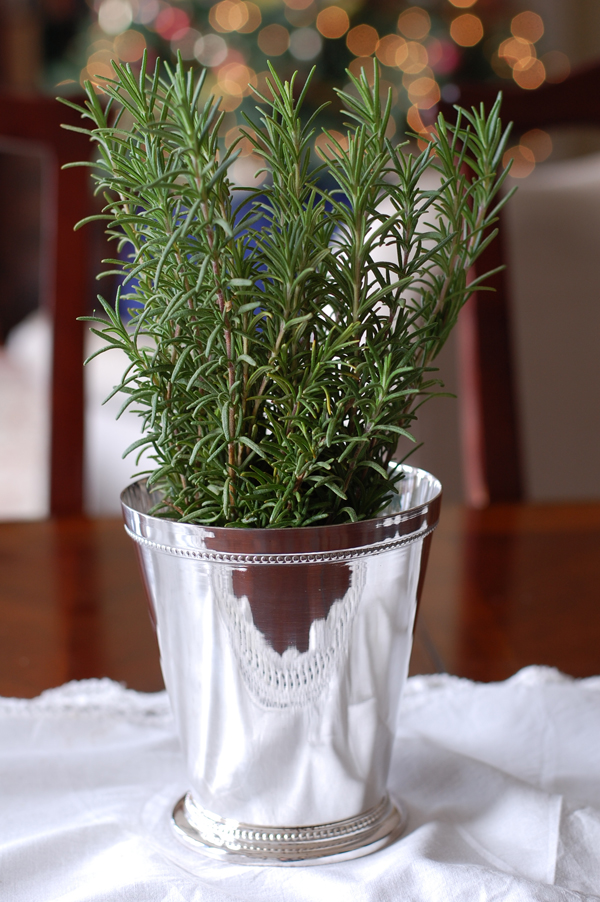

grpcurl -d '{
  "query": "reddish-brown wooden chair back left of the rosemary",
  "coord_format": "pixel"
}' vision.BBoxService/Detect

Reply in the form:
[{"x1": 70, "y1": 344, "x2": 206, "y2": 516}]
[{"x1": 0, "y1": 93, "x2": 92, "y2": 516}]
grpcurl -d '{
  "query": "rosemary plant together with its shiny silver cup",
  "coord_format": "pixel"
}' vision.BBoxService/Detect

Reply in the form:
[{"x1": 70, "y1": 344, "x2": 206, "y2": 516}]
[{"x1": 61, "y1": 60, "x2": 506, "y2": 863}]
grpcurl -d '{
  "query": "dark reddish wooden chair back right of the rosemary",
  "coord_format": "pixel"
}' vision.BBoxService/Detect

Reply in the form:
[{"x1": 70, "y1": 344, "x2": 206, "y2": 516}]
[{"x1": 441, "y1": 63, "x2": 600, "y2": 507}]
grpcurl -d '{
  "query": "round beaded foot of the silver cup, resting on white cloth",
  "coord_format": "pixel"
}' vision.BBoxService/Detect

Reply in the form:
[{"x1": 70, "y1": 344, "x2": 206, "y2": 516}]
[{"x1": 172, "y1": 792, "x2": 405, "y2": 867}]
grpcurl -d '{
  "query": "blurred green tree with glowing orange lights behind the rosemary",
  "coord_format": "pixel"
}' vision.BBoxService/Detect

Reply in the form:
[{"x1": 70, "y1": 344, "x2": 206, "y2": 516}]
[{"x1": 67, "y1": 0, "x2": 570, "y2": 152}]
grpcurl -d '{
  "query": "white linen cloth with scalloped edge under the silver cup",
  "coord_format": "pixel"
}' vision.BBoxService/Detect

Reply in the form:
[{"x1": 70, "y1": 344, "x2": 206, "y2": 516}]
[{"x1": 0, "y1": 667, "x2": 600, "y2": 902}]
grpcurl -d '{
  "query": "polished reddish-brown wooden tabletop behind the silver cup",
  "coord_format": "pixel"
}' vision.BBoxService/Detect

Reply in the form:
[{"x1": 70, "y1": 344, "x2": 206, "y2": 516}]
[{"x1": 0, "y1": 504, "x2": 600, "y2": 696}]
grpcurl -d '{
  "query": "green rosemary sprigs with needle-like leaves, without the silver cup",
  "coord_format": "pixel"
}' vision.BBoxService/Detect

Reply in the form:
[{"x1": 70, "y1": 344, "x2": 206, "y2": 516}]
[{"x1": 64, "y1": 60, "x2": 507, "y2": 527}]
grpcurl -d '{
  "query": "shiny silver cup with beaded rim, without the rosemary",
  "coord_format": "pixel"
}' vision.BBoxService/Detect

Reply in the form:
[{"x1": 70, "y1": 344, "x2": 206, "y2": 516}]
[{"x1": 122, "y1": 467, "x2": 441, "y2": 863}]
